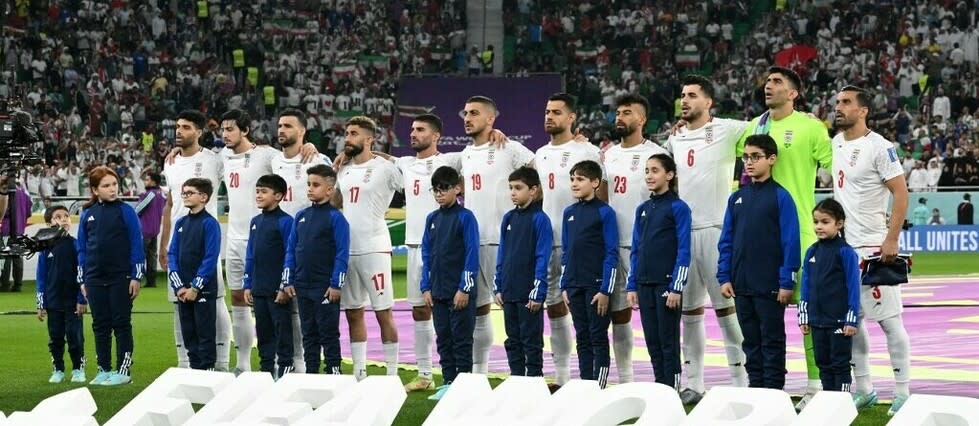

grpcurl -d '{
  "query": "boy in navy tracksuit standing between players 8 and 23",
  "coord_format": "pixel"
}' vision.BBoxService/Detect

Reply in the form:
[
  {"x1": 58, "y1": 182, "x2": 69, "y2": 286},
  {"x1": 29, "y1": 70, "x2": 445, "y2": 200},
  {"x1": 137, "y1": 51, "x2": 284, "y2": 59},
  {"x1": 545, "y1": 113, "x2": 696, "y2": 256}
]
[{"x1": 561, "y1": 160, "x2": 619, "y2": 389}]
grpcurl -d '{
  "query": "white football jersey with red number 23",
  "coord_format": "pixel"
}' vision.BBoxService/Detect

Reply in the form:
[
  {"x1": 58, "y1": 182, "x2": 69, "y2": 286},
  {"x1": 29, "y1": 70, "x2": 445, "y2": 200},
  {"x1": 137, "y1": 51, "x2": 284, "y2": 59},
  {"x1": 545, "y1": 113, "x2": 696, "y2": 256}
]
[{"x1": 602, "y1": 140, "x2": 666, "y2": 247}]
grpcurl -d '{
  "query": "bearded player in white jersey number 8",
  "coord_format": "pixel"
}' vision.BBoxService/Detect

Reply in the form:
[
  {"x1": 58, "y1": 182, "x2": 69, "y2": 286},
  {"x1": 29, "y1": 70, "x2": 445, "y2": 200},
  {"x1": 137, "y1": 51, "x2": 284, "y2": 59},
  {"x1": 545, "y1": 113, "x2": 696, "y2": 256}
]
[{"x1": 534, "y1": 93, "x2": 604, "y2": 386}]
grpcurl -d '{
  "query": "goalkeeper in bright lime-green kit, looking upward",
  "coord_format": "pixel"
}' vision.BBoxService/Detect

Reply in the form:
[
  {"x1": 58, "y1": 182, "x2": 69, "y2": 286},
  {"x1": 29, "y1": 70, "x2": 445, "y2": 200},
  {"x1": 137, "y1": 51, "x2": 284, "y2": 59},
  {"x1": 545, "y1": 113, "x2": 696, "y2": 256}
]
[{"x1": 737, "y1": 67, "x2": 833, "y2": 411}]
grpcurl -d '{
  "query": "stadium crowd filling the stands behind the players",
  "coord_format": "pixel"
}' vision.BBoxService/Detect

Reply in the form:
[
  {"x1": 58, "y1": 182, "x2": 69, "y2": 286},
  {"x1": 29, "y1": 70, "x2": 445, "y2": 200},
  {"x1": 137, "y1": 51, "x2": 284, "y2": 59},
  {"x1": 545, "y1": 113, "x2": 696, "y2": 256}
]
[{"x1": 0, "y1": 0, "x2": 979, "y2": 210}]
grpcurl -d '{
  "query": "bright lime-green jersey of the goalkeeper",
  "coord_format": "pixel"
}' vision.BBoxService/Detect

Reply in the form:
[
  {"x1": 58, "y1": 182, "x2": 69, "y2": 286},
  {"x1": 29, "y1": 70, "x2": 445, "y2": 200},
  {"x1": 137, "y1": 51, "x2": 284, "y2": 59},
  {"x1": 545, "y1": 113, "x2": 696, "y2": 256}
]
[{"x1": 737, "y1": 111, "x2": 833, "y2": 254}]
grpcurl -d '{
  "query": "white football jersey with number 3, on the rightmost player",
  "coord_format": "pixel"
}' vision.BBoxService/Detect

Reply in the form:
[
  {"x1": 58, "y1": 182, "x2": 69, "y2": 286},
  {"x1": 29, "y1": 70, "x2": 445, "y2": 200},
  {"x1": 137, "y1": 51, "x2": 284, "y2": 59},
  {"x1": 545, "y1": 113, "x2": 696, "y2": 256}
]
[{"x1": 833, "y1": 132, "x2": 904, "y2": 247}]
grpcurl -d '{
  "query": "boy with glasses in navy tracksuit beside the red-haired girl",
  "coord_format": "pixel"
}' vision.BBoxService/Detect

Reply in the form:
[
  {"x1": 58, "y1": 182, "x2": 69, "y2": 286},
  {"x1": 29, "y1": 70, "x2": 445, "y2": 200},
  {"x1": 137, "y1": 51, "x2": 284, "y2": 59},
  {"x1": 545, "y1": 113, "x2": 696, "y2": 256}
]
[{"x1": 167, "y1": 178, "x2": 221, "y2": 370}]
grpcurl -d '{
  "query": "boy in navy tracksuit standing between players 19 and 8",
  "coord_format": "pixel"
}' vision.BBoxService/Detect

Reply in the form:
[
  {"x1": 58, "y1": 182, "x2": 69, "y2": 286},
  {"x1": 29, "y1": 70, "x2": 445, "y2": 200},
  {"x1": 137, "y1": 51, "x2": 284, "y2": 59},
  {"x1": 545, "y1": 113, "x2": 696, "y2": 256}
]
[{"x1": 494, "y1": 167, "x2": 554, "y2": 376}]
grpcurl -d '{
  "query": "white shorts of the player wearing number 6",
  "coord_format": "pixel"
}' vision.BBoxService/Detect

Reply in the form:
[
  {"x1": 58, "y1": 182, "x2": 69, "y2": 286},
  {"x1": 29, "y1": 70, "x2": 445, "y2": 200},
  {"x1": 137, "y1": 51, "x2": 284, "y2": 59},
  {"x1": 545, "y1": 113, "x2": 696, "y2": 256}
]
[{"x1": 682, "y1": 228, "x2": 734, "y2": 311}]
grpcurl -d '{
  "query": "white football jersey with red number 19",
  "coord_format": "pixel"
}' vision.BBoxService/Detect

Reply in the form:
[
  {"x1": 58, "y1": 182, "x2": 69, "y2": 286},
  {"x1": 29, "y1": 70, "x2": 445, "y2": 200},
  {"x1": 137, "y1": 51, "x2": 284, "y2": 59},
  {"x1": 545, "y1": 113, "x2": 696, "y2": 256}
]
[{"x1": 462, "y1": 140, "x2": 534, "y2": 244}]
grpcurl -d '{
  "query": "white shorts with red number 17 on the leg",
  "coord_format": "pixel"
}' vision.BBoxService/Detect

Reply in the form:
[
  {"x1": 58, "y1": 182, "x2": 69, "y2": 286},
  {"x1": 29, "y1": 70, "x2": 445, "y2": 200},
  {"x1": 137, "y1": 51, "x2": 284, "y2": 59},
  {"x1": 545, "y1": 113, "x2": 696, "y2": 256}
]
[{"x1": 340, "y1": 253, "x2": 394, "y2": 311}]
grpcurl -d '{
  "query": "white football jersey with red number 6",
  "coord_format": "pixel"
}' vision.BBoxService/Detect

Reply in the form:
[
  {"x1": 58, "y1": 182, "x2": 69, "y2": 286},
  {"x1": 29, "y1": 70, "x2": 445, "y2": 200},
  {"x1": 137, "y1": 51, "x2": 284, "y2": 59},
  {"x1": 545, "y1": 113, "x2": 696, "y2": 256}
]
[{"x1": 666, "y1": 117, "x2": 751, "y2": 229}]
